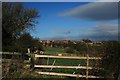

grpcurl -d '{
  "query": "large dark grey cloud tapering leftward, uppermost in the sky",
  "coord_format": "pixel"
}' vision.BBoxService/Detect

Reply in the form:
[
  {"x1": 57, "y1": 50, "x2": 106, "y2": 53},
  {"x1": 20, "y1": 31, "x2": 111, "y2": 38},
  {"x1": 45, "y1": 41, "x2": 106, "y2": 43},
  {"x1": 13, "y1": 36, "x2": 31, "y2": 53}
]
[{"x1": 61, "y1": 2, "x2": 118, "y2": 21}]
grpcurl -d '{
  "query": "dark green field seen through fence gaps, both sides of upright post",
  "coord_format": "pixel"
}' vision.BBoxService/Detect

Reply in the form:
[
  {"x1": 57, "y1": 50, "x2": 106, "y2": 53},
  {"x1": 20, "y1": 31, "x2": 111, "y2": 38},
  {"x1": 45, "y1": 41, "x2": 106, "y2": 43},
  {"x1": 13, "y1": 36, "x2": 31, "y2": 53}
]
[{"x1": 35, "y1": 55, "x2": 102, "y2": 76}]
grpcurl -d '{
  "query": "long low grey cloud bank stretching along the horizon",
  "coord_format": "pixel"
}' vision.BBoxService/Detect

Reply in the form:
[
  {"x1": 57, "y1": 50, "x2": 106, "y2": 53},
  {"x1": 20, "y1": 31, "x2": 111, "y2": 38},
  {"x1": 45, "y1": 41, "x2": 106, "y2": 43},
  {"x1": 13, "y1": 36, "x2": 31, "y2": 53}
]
[{"x1": 45, "y1": 23, "x2": 119, "y2": 40}]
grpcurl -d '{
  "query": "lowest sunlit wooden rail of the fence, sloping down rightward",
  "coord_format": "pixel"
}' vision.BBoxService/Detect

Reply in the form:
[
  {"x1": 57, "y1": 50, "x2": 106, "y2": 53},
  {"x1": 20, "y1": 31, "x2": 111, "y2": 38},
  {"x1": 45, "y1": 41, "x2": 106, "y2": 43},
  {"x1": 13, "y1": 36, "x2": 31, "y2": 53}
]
[{"x1": 35, "y1": 71, "x2": 104, "y2": 78}]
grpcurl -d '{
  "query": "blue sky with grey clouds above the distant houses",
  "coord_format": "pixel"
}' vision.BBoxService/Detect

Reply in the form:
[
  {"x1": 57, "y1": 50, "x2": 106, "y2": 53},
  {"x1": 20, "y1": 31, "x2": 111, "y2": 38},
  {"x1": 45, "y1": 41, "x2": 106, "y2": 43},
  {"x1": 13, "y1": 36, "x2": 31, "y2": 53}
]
[{"x1": 24, "y1": 2, "x2": 118, "y2": 40}]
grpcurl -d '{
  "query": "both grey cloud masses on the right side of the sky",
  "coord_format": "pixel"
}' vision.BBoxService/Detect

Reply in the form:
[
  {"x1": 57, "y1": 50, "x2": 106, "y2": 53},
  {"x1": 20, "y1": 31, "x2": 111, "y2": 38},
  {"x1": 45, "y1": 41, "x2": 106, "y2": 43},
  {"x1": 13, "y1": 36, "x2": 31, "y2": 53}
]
[{"x1": 58, "y1": 0, "x2": 119, "y2": 40}]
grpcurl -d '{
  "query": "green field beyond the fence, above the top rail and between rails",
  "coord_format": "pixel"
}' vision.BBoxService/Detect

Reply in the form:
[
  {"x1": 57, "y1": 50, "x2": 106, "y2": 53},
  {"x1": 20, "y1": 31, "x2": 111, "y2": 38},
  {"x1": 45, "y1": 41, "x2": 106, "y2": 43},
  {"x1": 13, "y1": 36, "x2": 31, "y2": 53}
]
[{"x1": 34, "y1": 47, "x2": 86, "y2": 73}]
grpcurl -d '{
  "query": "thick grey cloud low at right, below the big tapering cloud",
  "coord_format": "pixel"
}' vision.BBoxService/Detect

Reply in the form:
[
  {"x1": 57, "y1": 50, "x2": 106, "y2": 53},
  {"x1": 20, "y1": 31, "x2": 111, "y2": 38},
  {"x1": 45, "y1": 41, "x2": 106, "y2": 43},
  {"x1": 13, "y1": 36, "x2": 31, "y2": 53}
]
[{"x1": 79, "y1": 23, "x2": 119, "y2": 40}]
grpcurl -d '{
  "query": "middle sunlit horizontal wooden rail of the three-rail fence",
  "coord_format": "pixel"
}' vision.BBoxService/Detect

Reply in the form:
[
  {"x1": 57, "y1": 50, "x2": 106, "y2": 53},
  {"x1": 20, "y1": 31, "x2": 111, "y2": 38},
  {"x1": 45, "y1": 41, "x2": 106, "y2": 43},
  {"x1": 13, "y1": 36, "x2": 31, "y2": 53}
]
[{"x1": 34, "y1": 65, "x2": 102, "y2": 69}]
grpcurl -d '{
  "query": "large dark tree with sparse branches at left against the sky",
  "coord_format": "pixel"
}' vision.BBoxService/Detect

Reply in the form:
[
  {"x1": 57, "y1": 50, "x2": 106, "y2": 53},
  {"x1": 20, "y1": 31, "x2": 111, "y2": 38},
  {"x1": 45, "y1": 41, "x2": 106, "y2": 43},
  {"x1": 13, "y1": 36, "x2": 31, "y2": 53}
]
[{"x1": 2, "y1": 2, "x2": 43, "y2": 53}]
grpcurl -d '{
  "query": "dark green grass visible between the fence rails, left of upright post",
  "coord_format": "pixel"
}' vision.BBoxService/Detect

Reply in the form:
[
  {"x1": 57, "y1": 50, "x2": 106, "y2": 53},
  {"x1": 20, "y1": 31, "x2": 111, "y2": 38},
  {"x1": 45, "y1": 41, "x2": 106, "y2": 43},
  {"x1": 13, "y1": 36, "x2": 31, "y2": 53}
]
[{"x1": 37, "y1": 58, "x2": 86, "y2": 74}]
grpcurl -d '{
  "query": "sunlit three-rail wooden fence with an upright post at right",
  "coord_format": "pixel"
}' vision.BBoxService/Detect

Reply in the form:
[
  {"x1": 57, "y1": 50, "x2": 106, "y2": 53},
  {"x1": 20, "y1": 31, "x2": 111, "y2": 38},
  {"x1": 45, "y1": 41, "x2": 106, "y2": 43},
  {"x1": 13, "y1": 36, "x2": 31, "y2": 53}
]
[{"x1": 32, "y1": 54, "x2": 104, "y2": 79}]
